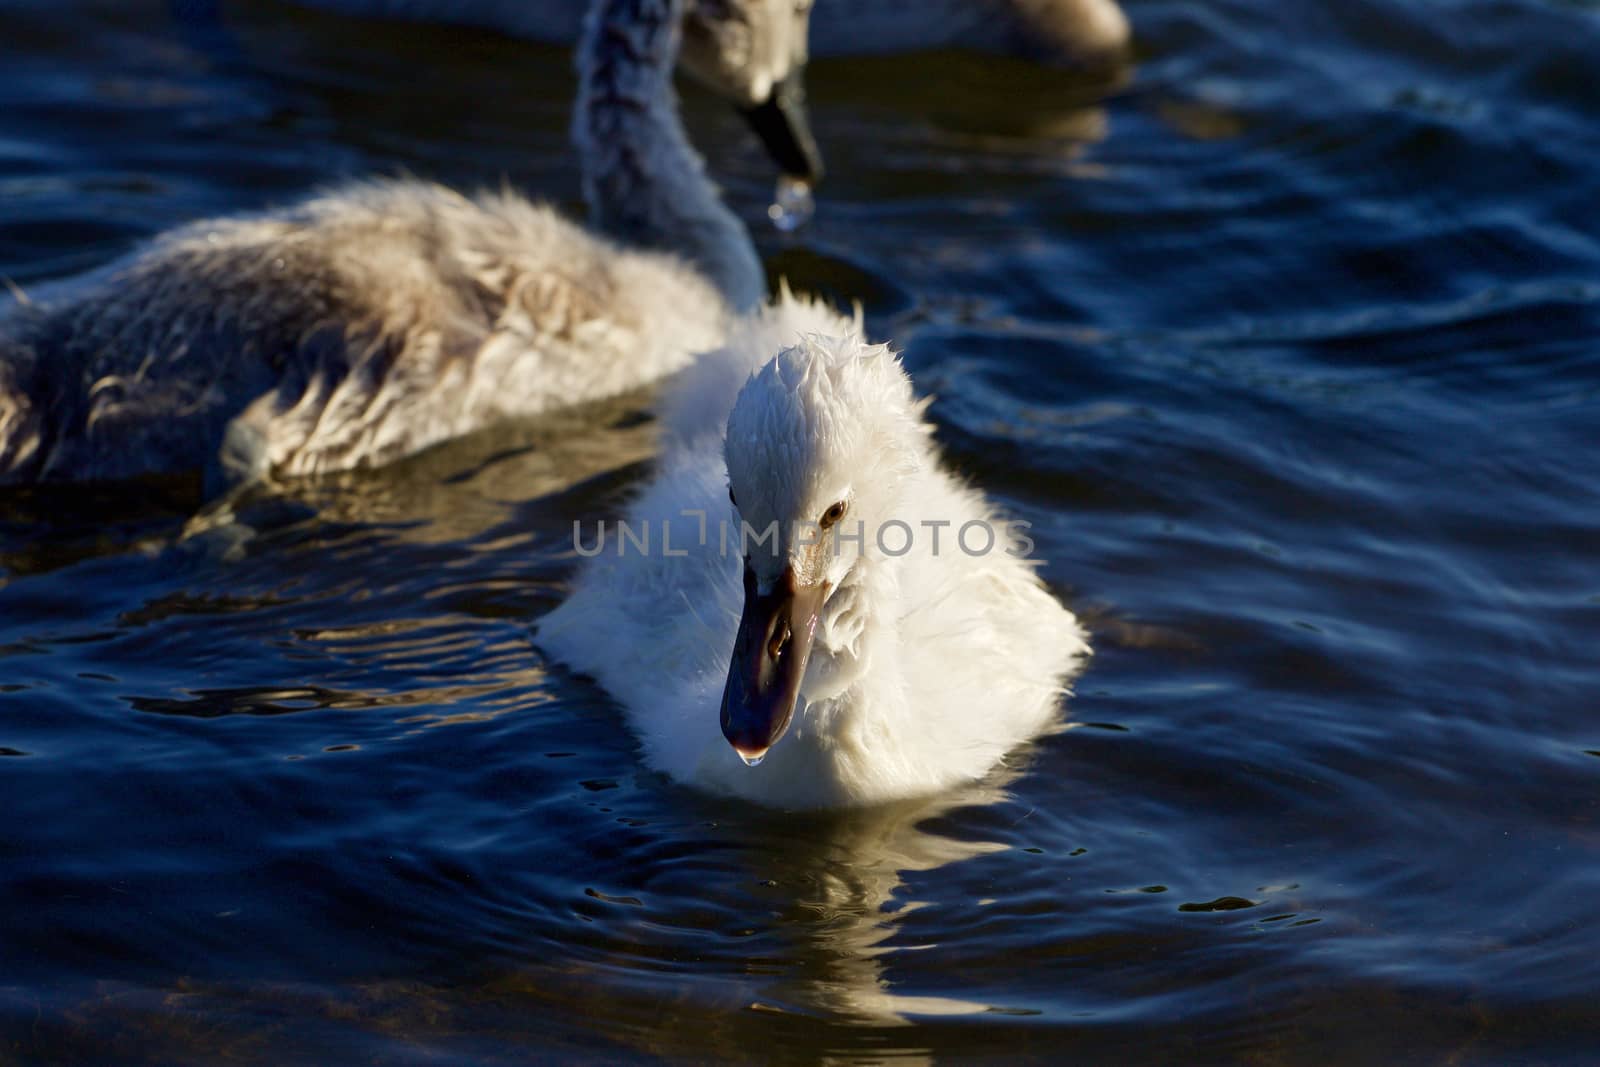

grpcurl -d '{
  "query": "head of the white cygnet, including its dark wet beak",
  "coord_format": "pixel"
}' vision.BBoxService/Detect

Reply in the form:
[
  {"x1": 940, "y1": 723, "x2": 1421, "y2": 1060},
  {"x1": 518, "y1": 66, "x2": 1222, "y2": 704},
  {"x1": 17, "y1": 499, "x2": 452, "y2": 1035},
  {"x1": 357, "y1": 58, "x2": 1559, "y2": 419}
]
[{"x1": 722, "y1": 336, "x2": 928, "y2": 765}]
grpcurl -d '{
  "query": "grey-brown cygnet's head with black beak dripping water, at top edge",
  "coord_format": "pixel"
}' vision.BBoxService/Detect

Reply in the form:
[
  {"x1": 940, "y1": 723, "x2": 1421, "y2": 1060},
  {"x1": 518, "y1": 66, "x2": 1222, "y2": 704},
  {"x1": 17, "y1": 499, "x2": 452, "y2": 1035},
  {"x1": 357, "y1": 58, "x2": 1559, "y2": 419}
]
[{"x1": 678, "y1": 0, "x2": 822, "y2": 184}]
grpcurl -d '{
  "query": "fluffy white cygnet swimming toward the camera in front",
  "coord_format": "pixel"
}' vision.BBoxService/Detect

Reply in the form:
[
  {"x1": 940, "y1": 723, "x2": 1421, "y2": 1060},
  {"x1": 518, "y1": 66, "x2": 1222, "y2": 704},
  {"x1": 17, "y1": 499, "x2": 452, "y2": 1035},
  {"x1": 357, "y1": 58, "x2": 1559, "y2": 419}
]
[{"x1": 539, "y1": 308, "x2": 1088, "y2": 808}]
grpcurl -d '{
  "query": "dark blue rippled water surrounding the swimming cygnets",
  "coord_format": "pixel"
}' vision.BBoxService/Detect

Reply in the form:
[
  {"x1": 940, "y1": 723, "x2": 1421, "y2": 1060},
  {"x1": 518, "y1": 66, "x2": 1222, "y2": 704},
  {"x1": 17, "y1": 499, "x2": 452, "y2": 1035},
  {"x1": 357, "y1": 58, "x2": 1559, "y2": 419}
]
[{"x1": 0, "y1": 0, "x2": 1600, "y2": 1064}]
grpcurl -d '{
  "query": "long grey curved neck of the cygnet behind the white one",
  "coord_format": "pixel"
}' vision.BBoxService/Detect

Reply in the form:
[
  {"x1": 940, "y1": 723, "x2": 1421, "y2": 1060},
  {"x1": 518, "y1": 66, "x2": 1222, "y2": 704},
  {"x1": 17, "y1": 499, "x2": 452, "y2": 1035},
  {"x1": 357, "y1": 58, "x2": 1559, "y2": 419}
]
[{"x1": 573, "y1": 0, "x2": 766, "y2": 310}]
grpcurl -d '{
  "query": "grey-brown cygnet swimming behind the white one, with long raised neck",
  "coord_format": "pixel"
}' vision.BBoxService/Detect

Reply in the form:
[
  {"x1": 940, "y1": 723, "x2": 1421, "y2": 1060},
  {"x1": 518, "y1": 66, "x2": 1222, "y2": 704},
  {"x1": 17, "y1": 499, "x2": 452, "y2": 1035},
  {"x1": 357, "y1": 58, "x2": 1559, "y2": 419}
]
[{"x1": 0, "y1": 0, "x2": 808, "y2": 491}]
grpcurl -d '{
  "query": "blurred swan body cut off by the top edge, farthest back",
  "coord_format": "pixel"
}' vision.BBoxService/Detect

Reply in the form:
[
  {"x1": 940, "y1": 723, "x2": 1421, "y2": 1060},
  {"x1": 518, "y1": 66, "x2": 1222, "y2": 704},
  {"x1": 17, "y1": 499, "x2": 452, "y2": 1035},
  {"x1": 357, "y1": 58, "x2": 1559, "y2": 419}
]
[{"x1": 299, "y1": 0, "x2": 1130, "y2": 66}]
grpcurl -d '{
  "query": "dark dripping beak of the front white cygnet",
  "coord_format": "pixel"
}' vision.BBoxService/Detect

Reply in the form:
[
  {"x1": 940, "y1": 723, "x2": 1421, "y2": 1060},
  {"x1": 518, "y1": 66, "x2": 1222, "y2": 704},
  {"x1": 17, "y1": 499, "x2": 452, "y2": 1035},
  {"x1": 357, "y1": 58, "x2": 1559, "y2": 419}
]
[{"x1": 722, "y1": 565, "x2": 827, "y2": 766}]
